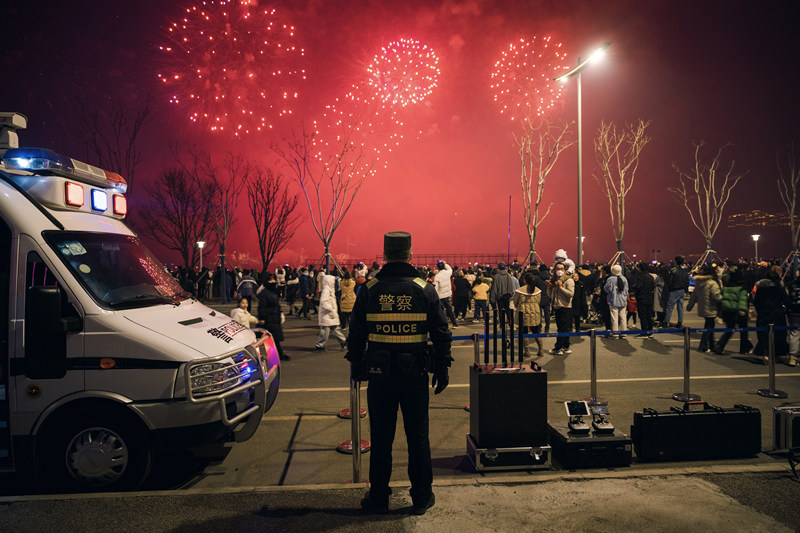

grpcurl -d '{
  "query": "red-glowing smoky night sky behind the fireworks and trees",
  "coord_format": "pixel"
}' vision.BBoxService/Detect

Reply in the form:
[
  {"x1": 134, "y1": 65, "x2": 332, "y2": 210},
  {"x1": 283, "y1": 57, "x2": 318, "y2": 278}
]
[{"x1": 0, "y1": 0, "x2": 800, "y2": 263}]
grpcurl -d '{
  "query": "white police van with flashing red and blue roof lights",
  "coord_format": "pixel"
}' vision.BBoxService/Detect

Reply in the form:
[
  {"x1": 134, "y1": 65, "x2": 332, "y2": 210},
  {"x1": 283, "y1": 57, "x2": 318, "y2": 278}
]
[{"x1": 0, "y1": 113, "x2": 280, "y2": 490}]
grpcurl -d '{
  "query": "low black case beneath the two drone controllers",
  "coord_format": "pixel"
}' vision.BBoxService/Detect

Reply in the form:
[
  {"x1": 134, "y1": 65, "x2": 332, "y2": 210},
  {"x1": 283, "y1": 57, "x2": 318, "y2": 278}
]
[{"x1": 549, "y1": 422, "x2": 631, "y2": 469}]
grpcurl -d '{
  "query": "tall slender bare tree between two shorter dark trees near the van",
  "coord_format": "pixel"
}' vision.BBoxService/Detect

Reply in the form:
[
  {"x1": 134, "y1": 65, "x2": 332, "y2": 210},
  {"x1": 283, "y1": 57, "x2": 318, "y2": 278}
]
[{"x1": 172, "y1": 146, "x2": 256, "y2": 303}]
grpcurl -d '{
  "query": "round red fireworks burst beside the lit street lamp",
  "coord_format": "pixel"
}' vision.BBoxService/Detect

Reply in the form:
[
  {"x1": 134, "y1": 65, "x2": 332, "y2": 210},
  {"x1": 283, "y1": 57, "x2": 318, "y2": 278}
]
[{"x1": 490, "y1": 37, "x2": 569, "y2": 120}]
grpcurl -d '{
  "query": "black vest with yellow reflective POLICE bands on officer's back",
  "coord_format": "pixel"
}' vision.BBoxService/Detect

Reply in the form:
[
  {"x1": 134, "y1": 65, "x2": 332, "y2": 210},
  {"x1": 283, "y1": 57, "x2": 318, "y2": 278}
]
[{"x1": 366, "y1": 278, "x2": 429, "y2": 352}]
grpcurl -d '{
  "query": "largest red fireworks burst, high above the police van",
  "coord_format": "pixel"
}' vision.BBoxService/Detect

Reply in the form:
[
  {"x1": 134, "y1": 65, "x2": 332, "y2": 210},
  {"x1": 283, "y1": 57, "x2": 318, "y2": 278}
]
[{"x1": 158, "y1": 0, "x2": 306, "y2": 136}]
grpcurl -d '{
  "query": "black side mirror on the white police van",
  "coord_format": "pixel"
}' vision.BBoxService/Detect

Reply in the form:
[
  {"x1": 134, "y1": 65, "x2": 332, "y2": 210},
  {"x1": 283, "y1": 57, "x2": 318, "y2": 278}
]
[{"x1": 25, "y1": 286, "x2": 67, "y2": 379}]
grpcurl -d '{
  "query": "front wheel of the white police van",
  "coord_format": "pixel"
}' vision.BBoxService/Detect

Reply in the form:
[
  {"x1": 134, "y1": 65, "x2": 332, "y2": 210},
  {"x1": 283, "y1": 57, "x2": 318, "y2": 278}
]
[{"x1": 41, "y1": 411, "x2": 153, "y2": 491}]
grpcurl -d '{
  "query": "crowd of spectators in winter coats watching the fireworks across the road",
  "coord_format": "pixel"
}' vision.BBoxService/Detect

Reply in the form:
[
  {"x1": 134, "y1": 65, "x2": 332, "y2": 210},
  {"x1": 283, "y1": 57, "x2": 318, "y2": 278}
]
[{"x1": 167, "y1": 250, "x2": 800, "y2": 366}]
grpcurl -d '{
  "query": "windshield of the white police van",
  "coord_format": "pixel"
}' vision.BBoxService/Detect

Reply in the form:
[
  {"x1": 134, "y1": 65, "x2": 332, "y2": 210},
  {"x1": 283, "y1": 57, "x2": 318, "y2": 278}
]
[{"x1": 44, "y1": 231, "x2": 189, "y2": 309}]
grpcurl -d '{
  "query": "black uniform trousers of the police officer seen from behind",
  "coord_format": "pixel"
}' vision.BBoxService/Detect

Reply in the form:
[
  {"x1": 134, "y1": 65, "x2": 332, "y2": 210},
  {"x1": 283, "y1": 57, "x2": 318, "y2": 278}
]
[{"x1": 367, "y1": 372, "x2": 433, "y2": 503}]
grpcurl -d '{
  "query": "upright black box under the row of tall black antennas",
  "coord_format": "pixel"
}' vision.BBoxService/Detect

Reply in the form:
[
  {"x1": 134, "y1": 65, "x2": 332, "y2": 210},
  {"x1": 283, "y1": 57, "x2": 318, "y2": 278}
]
[{"x1": 469, "y1": 365, "x2": 547, "y2": 448}]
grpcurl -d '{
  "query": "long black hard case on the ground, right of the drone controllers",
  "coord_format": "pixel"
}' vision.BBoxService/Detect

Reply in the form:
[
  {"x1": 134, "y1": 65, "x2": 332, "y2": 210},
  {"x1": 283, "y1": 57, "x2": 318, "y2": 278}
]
[{"x1": 631, "y1": 402, "x2": 761, "y2": 461}]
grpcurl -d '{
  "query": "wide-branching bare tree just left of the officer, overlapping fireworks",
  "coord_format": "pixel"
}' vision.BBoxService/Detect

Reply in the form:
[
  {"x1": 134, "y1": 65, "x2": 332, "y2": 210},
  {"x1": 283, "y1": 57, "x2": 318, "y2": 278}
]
[{"x1": 272, "y1": 122, "x2": 376, "y2": 271}]
